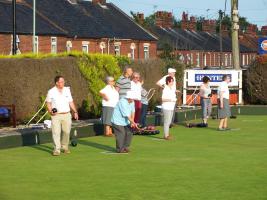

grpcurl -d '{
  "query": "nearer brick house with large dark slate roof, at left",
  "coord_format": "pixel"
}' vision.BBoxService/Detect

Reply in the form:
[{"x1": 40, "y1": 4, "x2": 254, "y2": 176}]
[{"x1": 0, "y1": 0, "x2": 157, "y2": 59}]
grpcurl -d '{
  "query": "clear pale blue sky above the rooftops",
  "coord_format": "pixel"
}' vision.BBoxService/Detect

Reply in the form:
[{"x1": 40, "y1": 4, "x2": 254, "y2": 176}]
[{"x1": 107, "y1": 0, "x2": 267, "y2": 27}]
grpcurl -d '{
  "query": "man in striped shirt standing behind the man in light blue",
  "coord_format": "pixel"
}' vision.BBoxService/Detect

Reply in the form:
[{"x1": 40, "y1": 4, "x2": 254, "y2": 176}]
[{"x1": 116, "y1": 67, "x2": 133, "y2": 98}]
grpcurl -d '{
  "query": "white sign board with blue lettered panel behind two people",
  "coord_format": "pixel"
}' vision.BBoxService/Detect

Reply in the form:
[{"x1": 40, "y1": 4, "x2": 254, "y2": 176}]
[{"x1": 186, "y1": 70, "x2": 241, "y2": 87}]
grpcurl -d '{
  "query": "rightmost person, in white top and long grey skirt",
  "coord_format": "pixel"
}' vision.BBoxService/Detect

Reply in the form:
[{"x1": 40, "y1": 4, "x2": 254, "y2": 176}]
[{"x1": 218, "y1": 75, "x2": 231, "y2": 131}]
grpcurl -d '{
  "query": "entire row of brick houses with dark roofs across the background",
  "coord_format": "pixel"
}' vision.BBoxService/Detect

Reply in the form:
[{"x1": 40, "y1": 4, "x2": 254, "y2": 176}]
[{"x1": 0, "y1": 0, "x2": 264, "y2": 68}]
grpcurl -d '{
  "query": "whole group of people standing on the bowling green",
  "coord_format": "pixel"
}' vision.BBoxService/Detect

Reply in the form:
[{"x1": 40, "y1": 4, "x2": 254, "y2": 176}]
[{"x1": 46, "y1": 67, "x2": 230, "y2": 156}]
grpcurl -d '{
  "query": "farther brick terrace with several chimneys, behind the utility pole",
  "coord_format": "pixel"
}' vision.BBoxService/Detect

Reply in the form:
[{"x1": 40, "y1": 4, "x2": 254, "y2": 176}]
[{"x1": 151, "y1": 11, "x2": 257, "y2": 68}]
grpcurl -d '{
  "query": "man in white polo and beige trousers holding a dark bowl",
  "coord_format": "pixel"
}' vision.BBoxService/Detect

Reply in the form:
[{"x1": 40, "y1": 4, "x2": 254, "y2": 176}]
[{"x1": 46, "y1": 76, "x2": 78, "y2": 156}]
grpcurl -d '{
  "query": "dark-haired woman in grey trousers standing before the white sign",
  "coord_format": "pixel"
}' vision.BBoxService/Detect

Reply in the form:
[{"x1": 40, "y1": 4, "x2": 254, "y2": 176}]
[{"x1": 199, "y1": 76, "x2": 212, "y2": 126}]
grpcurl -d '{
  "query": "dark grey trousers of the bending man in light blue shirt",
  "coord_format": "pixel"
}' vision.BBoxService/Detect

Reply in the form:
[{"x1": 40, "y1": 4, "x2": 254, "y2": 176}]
[{"x1": 112, "y1": 124, "x2": 133, "y2": 152}]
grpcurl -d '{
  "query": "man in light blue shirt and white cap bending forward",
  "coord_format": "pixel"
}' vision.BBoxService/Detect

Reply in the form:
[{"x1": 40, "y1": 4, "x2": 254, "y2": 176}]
[{"x1": 111, "y1": 91, "x2": 137, "y2": 153}]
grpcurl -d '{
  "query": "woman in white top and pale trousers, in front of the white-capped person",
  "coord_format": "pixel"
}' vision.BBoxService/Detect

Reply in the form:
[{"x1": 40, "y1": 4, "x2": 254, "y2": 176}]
[{"x1": 162, "y1": 76, "x2": 177, "y2": 140}]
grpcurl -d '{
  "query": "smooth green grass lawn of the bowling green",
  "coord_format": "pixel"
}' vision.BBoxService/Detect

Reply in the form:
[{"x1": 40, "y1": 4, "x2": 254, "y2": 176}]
[{"x1": 0, "y1": 116, "x2": 267, "y2": 200}]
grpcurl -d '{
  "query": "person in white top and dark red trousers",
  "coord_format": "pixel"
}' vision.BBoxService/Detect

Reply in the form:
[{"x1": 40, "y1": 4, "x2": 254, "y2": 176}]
[{"x1": 131, "y1": 72, "x2": 142, "y2": 123}]
